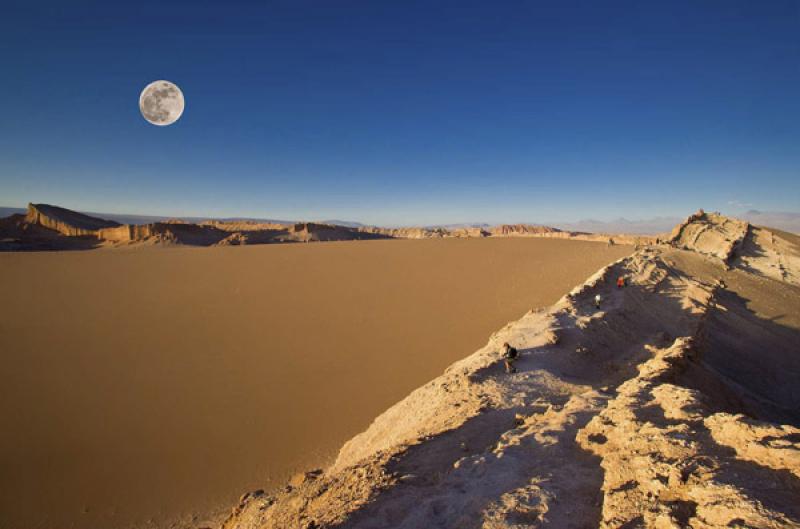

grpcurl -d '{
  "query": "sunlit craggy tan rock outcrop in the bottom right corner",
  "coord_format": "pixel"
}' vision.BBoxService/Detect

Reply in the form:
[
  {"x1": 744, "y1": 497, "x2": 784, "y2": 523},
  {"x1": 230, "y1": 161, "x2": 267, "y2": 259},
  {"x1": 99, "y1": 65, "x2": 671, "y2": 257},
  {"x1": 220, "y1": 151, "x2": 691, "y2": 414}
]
[{"x1": 577, "y1": 338, "x2": 800, "y2": 528}]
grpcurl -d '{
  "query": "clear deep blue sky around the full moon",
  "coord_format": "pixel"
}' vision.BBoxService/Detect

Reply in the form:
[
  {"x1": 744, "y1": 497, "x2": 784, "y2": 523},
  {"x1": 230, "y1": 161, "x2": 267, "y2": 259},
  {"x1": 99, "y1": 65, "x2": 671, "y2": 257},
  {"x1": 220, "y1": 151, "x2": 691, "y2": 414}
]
[{"x1": 0, "y1": 0, "x2": 800, "y2": 224}]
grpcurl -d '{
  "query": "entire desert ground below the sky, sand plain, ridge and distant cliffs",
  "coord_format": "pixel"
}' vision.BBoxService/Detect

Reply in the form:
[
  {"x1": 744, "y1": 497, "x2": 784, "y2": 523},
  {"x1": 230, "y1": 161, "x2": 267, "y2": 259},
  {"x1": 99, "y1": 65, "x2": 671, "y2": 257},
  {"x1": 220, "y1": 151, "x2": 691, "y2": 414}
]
[{"x1": 0, "y1": 204, "x2": 800, "y2": 529}]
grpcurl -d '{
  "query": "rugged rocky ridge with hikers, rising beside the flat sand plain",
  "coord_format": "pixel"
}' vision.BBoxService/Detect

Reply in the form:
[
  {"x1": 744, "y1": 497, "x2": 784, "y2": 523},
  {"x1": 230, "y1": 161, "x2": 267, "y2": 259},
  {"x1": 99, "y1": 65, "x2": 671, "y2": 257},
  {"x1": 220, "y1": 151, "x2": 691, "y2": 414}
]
[{"x1": 225, "y1": 212, "x2": 800, "y2": 529}]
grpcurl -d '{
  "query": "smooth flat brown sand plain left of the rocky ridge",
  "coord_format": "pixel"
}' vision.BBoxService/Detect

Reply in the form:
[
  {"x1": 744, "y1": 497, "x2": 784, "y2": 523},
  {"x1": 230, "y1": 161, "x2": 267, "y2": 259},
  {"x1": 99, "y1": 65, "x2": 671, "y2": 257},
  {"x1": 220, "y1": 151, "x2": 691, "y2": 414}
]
[{"x1": 0, "y1": 239, "x2": 631, "y2": 529}]
